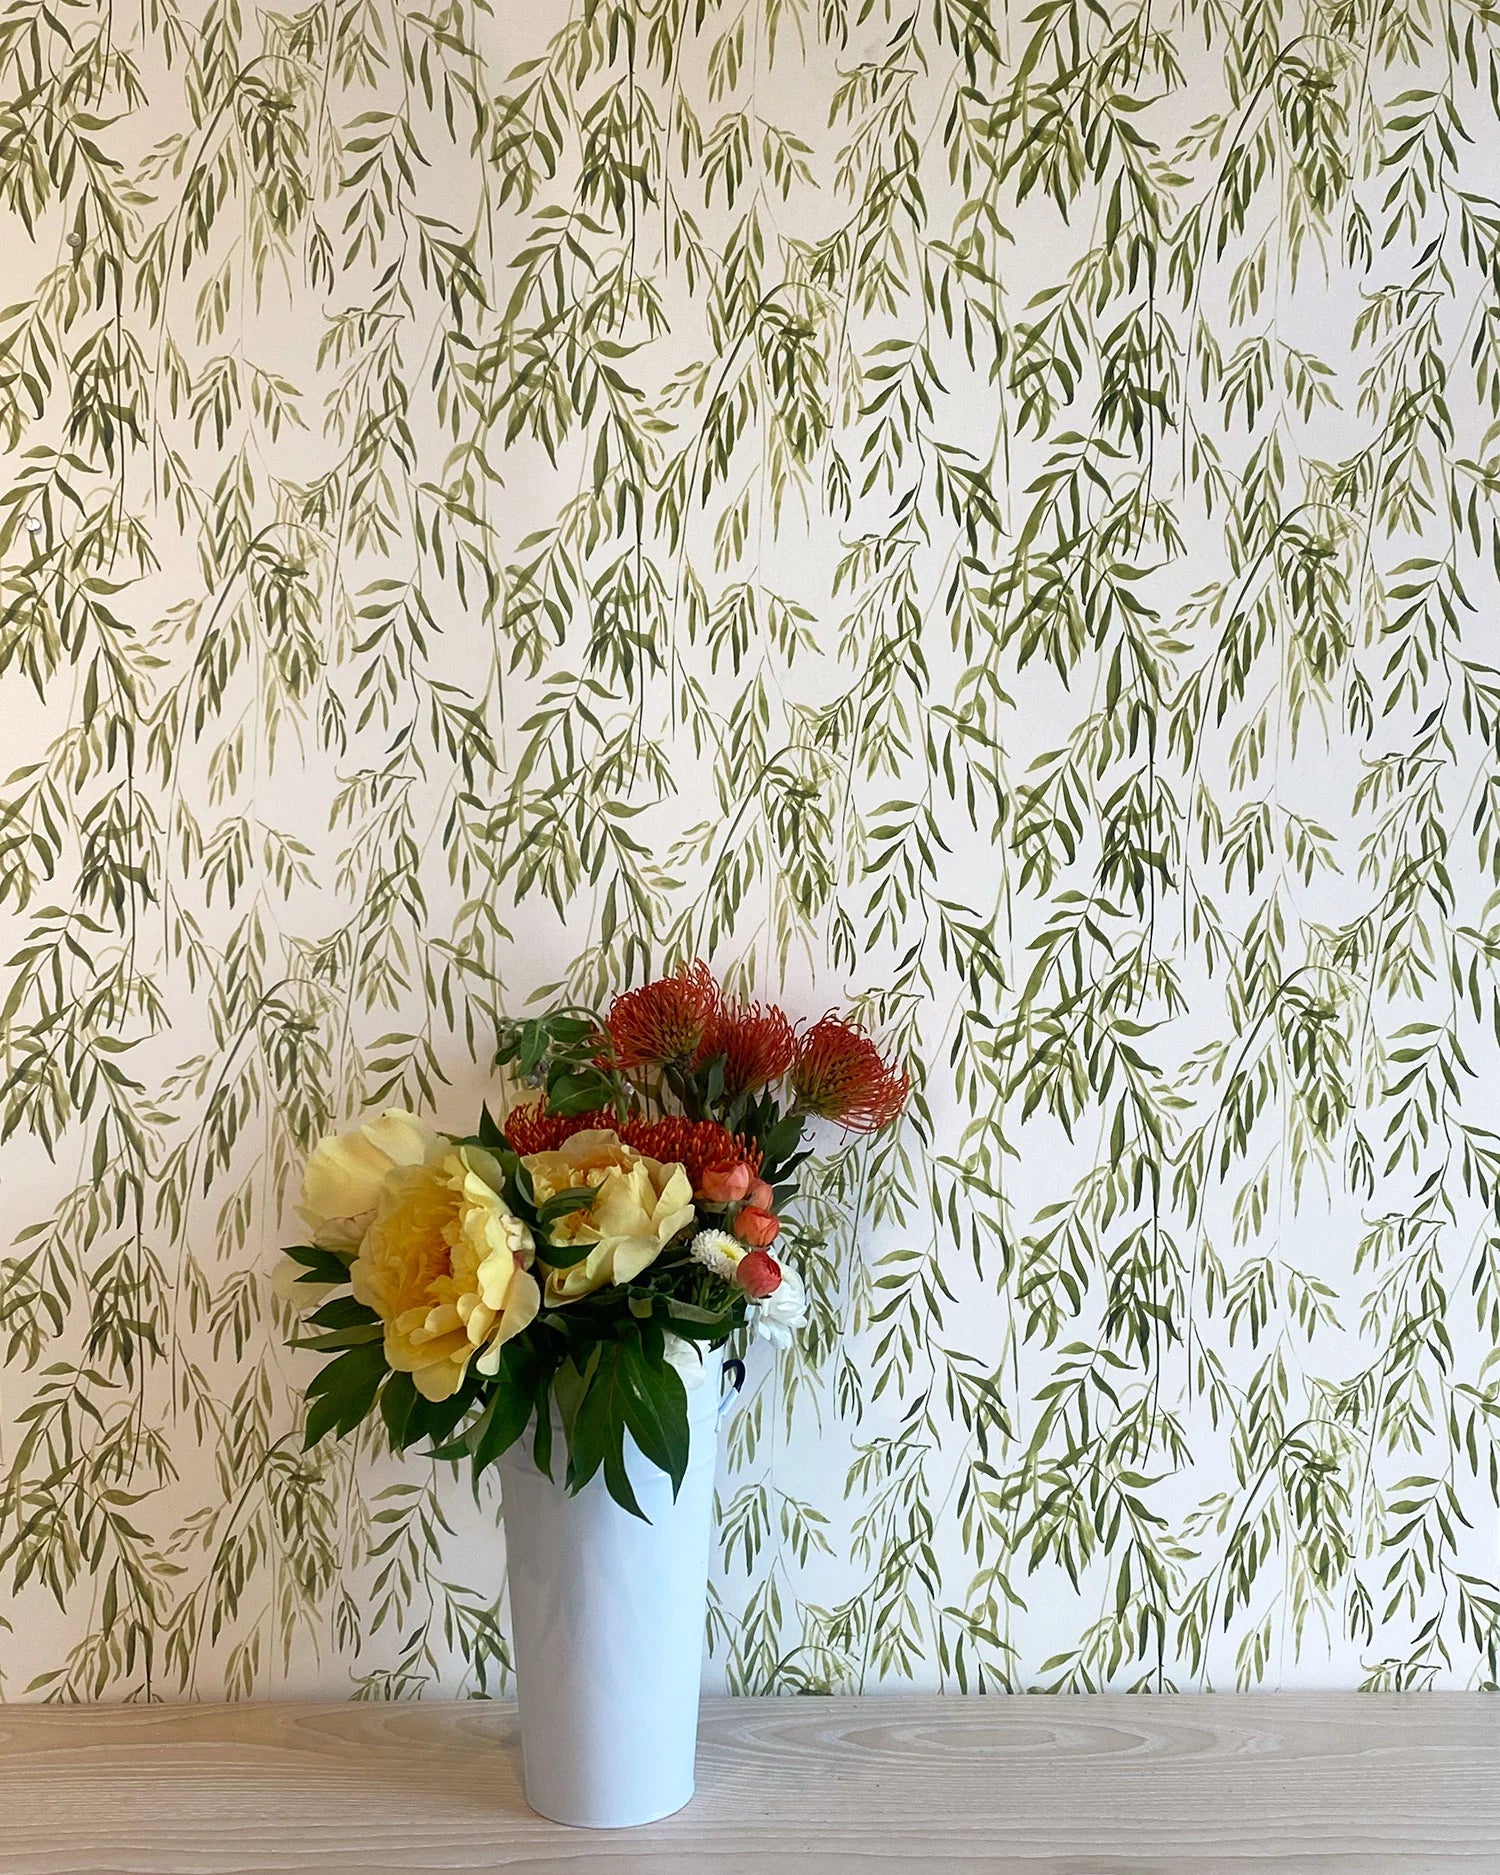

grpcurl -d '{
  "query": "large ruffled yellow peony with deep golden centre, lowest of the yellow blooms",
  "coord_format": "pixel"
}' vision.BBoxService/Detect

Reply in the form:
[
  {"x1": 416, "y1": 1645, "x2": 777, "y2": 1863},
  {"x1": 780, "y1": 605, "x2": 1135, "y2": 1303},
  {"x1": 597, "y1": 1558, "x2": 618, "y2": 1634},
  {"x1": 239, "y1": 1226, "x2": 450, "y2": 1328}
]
[{"x1": 349, "y1": 1146, "x2": 542, "y2": 1401}]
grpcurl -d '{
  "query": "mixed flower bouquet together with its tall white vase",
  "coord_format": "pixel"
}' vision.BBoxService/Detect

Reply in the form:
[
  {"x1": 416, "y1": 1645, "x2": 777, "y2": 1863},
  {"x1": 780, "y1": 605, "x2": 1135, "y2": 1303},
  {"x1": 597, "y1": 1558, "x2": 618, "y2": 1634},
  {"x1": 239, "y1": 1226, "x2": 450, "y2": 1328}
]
[{"x1": 287, "y1": 964, "x2": 908, "y2": 1824}]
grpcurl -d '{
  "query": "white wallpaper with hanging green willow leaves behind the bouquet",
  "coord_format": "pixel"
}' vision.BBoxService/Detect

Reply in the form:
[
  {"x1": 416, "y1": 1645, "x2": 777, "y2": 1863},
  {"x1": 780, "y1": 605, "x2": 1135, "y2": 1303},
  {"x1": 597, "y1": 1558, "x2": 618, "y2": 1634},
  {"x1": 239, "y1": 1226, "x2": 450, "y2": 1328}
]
[{"x1": 0, "y1": 0, "x2": 1500, "y2": 1699}]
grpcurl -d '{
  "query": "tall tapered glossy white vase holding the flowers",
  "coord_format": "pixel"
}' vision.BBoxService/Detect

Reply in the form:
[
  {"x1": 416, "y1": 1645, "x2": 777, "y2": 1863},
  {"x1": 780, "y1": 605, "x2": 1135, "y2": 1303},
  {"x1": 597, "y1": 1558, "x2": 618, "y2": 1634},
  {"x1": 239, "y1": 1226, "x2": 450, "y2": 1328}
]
[{"x1": 501, "y1": 1350, "x2": 728, "y2": 1830}]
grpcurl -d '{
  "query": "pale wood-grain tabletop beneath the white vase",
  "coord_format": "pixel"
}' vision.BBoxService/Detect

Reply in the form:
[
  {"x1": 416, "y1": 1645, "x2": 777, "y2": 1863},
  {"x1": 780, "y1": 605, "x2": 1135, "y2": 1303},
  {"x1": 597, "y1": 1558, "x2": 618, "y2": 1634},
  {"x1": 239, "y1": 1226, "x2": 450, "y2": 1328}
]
[{"x1": 0, "y1": 1693, "x2": 1500, "y2": 1875}]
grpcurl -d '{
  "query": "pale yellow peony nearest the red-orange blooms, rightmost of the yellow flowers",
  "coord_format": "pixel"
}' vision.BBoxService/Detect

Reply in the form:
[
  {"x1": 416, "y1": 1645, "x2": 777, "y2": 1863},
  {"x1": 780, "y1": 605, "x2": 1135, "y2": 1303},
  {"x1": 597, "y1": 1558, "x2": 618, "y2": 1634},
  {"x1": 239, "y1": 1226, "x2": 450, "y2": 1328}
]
[{"x1": 521, "y1": 1129, "x2": 694, "y2": 1305}]
